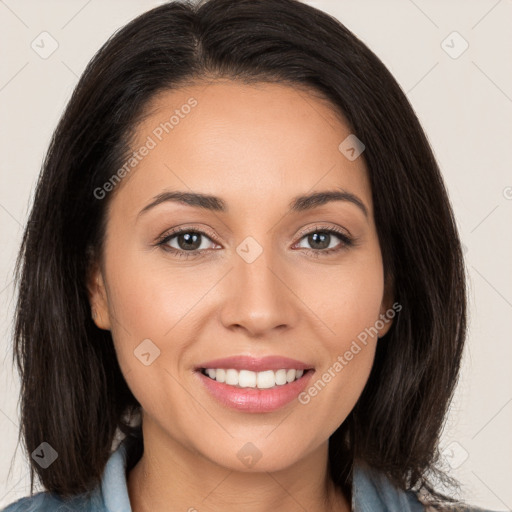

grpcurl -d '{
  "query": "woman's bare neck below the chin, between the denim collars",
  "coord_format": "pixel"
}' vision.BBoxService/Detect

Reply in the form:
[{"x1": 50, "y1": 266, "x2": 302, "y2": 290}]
[{"x1": 127, "y1": 421, "x2": 350, "y2": 512}]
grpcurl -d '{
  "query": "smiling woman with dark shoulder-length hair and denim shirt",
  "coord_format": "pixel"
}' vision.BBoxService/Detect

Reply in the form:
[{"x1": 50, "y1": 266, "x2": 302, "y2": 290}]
[{"x1": 0, "y1": 0, "x2": 496, "y2": 512}]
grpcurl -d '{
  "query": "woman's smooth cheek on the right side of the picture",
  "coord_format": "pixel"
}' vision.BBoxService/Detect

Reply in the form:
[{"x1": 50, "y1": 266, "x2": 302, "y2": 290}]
[{"x1": 299, "y1": 251, "x2": 384, "y2": 420}]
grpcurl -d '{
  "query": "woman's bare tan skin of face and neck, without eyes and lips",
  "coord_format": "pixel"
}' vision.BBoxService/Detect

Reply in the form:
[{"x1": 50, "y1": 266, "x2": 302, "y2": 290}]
[{"x1": 89, "y1": 81, "x2": 392, "y2": 512}]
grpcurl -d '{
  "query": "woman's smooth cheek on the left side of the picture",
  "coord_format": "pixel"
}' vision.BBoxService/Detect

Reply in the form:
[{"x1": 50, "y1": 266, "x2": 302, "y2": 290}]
[{"x1": 102, "y1": 242, "x2": 224, "y2": 416}]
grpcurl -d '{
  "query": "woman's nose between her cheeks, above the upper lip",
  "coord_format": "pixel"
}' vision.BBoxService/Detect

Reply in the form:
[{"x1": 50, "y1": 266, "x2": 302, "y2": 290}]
[{"x1": 220, "y1": 249, "x2": 299, "y2": 338}]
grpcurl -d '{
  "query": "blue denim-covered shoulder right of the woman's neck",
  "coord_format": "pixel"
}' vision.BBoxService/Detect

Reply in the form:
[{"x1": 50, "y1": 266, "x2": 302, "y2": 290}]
[{"x1": 352, "y1": 464, "x2": 498, "y2": 512}]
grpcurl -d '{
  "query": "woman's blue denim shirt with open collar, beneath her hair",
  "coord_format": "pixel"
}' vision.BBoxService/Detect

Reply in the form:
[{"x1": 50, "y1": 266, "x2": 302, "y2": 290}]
[{"x1": 2, "y1": 443, "x2": 496, "y2": 512}]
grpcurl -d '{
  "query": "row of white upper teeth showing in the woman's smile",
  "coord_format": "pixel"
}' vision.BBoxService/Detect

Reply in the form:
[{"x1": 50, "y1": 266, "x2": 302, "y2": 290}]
[{"x1": 202, "y1": 368, "x2": 304, "y2": 389}]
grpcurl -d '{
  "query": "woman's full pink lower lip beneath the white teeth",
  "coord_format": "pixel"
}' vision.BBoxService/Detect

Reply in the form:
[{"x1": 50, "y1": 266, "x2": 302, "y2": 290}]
[{"x1": 196, "y1": 370, "x2": 314, "y2": 413}]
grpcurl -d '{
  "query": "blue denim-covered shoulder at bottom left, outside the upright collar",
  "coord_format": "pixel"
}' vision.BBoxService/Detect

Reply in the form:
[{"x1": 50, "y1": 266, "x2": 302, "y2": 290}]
[{"x1": 0, "y1": 492, "x2": 106, "y2": 512}]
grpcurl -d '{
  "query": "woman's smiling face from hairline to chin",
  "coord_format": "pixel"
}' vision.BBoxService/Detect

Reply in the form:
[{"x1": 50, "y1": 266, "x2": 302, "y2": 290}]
[{"x1": 90, "y1": 81, "x2": 391, "y2": 471}]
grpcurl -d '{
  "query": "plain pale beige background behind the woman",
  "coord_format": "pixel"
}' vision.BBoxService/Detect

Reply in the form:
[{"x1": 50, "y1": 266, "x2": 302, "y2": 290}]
[{"x1": 0, "y1": 0, "x2": 512, "y2": 511}]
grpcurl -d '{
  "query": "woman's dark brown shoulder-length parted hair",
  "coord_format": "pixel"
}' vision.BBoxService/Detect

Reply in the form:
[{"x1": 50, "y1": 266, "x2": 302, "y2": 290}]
[{"x1": 14, "y1": 0, "x2": 466, "y2": 502}]
